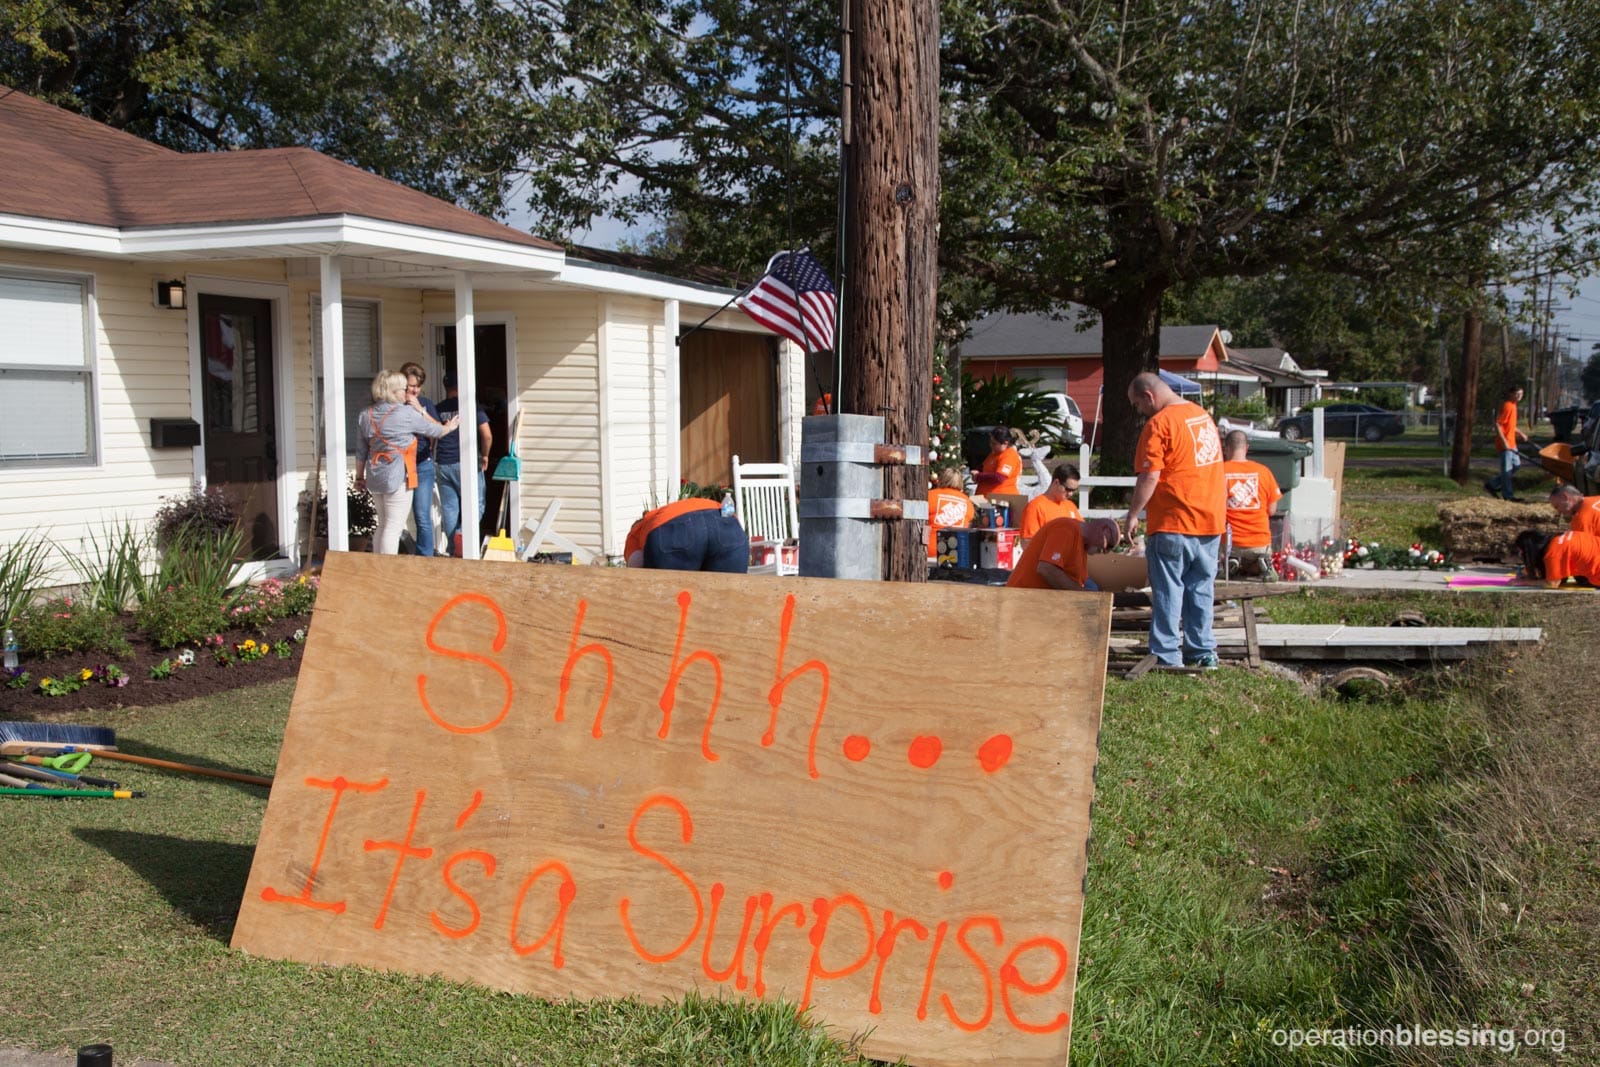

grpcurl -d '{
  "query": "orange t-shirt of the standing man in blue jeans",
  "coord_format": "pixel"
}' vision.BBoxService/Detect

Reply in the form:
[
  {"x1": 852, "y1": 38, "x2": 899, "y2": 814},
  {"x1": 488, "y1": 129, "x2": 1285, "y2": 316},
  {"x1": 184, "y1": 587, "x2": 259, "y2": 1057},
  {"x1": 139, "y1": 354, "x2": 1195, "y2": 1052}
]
[{"x1": 1133, "y1": 400, "x2": 1227, "y2": 537}]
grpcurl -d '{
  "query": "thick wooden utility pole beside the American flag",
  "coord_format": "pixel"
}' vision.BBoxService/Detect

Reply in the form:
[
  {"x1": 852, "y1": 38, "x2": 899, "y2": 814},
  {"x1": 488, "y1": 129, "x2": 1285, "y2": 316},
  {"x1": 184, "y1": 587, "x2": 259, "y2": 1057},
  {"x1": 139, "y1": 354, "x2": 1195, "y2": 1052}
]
[{"x1": 840, "y1": 0, "x2": 939, "y2": 582}]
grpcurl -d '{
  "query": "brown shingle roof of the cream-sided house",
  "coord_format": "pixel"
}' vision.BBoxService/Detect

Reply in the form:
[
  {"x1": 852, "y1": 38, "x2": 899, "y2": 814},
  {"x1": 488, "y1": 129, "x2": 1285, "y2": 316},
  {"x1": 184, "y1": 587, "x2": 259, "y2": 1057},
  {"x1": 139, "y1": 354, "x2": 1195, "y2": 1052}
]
[{"x1": 0, "y1": 86, "x2": 560, "y2": 251}]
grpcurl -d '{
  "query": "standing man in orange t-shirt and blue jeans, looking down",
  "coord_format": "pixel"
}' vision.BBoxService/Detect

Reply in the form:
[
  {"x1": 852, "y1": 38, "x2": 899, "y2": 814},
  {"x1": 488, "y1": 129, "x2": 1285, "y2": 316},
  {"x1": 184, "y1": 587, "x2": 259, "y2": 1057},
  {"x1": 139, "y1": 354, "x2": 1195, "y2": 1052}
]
[{"x1": 1128, "y1": 371, "x2": 1227, "y2": 670}]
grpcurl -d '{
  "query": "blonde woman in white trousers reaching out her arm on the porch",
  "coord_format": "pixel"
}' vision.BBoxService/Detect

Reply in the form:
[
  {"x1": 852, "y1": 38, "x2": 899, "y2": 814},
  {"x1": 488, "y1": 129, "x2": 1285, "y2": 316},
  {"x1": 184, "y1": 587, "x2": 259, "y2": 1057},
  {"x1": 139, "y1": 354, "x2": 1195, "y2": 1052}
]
[{"x1": 355, "y1": 370, "x2": 458, "y2": 555}]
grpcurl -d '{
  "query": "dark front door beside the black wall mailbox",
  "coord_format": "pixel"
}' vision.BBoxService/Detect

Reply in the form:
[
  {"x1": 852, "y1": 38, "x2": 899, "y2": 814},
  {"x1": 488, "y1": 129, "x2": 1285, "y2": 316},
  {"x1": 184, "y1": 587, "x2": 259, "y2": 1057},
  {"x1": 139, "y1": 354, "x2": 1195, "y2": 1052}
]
[{"x1": 200, "y1": 296, "x2": 278, "y2": 560}]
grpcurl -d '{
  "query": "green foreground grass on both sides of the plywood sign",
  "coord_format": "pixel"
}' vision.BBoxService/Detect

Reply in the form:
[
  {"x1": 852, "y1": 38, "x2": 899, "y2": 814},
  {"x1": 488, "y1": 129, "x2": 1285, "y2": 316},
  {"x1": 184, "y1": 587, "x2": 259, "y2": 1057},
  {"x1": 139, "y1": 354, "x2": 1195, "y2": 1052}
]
[{"x1": 0, "y1": 655, "x2": 1497, "y2": 1065}]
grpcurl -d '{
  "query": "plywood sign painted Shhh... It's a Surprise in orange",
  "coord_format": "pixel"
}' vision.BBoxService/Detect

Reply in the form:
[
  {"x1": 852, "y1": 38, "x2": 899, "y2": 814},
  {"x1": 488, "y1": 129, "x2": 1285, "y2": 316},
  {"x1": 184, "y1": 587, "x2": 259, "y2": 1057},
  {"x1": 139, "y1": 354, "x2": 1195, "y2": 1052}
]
[{"x1": 234, "y1": 553, "x2": 1110, "y2": 1065}]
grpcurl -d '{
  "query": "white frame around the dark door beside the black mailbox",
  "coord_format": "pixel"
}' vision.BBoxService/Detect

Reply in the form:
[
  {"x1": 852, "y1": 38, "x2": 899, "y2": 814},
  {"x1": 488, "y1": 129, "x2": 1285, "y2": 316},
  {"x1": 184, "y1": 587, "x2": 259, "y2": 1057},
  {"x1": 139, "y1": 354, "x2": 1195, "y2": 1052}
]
[{"x1": 186, "y1": 274, "x2": 299, "y2": 563}]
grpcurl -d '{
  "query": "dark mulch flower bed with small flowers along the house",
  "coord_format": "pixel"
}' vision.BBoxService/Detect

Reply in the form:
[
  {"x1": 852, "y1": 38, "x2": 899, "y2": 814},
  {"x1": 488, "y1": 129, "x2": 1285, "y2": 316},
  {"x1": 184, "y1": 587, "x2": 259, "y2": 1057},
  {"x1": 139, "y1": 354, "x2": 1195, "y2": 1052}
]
[{"x1": 0, "y1": 616, "x2": 310, "y2": 721}]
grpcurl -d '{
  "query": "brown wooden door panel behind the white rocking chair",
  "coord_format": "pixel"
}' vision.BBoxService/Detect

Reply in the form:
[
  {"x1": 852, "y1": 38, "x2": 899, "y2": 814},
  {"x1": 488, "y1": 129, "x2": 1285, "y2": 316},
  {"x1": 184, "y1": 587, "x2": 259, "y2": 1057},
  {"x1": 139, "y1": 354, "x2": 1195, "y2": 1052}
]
[{"x1": 678, "y1": 330, "x2": 779, "y2": 485}]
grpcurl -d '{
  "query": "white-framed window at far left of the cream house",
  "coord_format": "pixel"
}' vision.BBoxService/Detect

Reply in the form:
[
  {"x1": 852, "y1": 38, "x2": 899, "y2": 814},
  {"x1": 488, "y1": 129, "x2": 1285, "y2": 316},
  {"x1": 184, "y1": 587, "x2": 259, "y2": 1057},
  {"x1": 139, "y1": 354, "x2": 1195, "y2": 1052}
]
[{"x1": 0, "y1": 274, "x2": 96, "y2": 467}]
